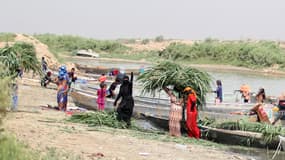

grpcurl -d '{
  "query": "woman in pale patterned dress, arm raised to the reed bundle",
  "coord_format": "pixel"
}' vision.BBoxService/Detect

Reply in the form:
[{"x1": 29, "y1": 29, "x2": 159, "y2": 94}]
[{"x1": 163, "y1": 87, "x2": 182, "y2": 137}]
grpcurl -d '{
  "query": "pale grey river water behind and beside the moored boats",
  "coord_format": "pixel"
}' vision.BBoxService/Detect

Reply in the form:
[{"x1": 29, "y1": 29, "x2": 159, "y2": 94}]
[{"x1": 70, "y1": 58, "x2": 285, "y2": 160}]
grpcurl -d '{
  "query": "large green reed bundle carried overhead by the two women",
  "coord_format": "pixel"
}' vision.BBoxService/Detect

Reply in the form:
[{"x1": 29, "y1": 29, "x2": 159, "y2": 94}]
[{"x1": 138, "y1": 61, "x2": 211, "y2": 105}]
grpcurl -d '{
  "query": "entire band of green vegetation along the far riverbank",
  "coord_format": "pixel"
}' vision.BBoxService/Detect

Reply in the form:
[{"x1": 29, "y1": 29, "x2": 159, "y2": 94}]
[{"x1": 31, "y1": 34, "x2": 285, "y2": 68}]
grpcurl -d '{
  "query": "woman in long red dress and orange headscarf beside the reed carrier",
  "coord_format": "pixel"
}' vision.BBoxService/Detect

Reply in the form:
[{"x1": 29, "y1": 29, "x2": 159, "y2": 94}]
[{"x1": 184, "y1": 87, "x2": 200, "y2": 139}]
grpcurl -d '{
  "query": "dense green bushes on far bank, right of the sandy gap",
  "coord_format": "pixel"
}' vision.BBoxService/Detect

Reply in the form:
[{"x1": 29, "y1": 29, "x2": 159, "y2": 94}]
[{"x1": 159, "y1": 39, "x2": 285, "y2": 68}]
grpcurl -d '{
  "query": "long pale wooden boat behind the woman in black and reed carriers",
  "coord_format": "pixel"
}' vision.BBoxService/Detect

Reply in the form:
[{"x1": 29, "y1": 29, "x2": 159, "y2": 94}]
[{"x1": 70, "y1": 88, "x2": 252, "y2": 120}]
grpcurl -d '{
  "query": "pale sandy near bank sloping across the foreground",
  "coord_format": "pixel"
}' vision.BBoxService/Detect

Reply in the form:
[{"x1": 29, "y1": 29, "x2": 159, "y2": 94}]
[{"x1": 5, "y1": 81, "x2": 246, "y2": 160}]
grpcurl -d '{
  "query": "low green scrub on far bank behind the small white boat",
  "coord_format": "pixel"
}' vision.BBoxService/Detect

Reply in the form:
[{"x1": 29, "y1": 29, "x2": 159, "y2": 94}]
[{"x1": 34, "y1": 34, "x2": 130, "y2": 53}]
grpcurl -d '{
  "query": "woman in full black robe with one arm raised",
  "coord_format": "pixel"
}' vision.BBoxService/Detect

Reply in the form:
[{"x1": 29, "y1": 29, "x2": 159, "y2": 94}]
[{"x1": 114, "y1": 72, "x2": 134, "y2": 126}]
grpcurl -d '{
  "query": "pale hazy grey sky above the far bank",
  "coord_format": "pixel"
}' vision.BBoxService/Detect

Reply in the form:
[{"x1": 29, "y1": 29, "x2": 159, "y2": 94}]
[{"x1": 0, "y1": 0, "x2": 285, "y2": 40}]
